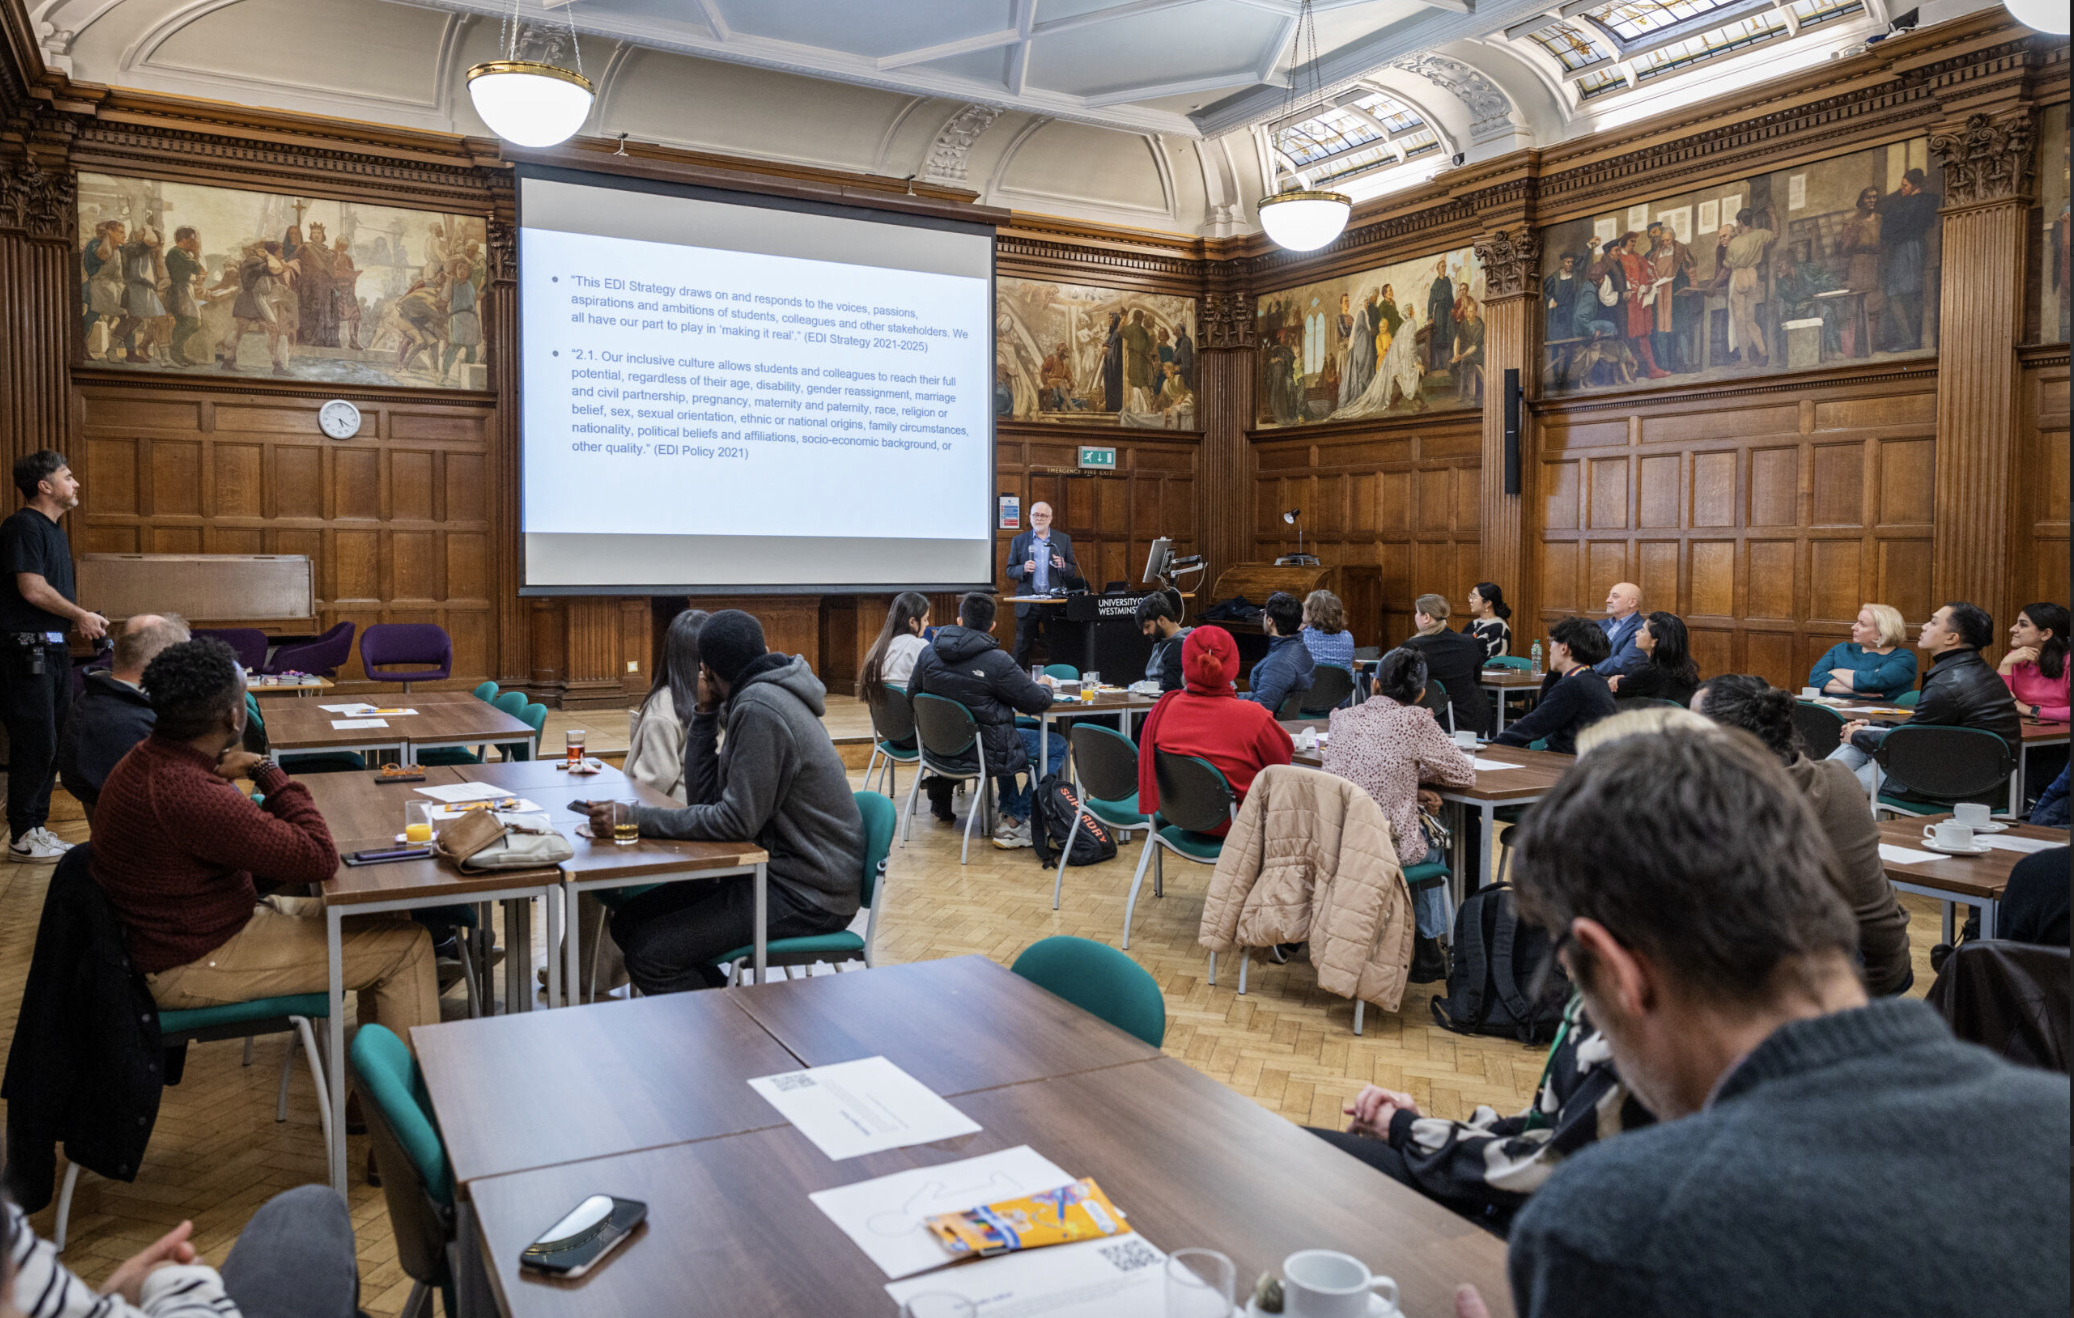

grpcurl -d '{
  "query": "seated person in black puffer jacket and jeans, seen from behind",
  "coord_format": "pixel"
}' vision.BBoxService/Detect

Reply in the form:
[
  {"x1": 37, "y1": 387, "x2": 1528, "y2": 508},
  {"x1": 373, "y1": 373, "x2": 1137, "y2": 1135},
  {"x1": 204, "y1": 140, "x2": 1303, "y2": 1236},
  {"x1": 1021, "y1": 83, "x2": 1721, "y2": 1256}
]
[{"x1": 908, "y1": 592, "x2": 1066, "y2": 849}]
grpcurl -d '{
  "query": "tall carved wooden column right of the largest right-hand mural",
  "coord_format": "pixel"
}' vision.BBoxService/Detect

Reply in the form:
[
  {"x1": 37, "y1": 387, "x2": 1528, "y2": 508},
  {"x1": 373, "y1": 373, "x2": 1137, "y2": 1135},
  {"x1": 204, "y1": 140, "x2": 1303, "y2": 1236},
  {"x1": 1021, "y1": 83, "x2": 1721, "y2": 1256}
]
[{"x1": 1931, "y1": 106, "x2": 2035, "y2": 629}]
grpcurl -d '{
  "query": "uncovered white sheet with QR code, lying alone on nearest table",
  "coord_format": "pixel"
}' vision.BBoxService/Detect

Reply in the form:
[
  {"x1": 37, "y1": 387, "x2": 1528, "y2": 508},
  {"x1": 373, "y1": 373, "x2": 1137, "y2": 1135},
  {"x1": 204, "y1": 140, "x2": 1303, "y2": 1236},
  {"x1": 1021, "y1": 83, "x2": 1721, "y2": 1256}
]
[{"x1": 749, "y1": 1056, "x2": 978, "y2": 1183}]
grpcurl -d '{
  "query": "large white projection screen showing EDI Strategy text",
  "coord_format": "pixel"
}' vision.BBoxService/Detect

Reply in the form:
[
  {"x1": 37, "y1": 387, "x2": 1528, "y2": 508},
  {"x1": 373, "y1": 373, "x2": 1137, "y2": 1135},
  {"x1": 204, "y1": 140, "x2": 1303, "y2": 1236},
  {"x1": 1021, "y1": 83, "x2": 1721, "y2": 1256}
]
[{"x1": 519, "y1": 166, "x2": 993, "y2": 596}]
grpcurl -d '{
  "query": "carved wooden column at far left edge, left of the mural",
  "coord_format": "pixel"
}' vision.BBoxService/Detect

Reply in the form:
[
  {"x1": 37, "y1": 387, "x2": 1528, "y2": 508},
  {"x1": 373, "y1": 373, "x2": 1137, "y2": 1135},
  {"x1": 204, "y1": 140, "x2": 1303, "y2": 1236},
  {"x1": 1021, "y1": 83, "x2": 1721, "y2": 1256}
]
[{"x1": 0, "y1": 154, "x2": 75, "y2": 469}]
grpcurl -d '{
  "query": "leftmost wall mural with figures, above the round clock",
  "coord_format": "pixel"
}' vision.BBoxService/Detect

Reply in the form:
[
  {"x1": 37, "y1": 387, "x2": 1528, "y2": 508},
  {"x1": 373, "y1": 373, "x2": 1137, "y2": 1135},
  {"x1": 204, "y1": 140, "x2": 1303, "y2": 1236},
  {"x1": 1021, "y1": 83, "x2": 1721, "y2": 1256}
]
[{"x1": 77, "y1": 174, "x2": 489, "y2": 388}]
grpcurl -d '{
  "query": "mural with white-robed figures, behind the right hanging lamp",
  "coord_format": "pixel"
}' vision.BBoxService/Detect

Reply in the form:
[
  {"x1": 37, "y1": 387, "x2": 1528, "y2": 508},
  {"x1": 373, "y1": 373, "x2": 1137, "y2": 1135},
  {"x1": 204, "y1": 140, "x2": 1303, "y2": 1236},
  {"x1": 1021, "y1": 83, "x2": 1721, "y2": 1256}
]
[{"x1": 1253, "y1": 247, "x2": 1485, "y2": 428}]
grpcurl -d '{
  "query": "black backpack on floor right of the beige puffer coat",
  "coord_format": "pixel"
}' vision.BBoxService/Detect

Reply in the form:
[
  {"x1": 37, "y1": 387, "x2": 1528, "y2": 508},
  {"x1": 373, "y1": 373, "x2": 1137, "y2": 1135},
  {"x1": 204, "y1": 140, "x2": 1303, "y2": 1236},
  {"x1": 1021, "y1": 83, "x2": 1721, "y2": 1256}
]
[{"x1": 1433, "y1": 884, "x2": 1570, "y2": 1044}]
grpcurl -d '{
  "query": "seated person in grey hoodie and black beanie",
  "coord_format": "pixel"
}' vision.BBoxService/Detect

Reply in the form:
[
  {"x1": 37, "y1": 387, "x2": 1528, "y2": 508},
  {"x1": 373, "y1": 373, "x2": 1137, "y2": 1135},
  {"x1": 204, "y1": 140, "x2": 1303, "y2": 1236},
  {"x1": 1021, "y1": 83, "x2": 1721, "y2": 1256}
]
[{"x1": 591, "y1": 608, "x2": 865, "y2": 994}]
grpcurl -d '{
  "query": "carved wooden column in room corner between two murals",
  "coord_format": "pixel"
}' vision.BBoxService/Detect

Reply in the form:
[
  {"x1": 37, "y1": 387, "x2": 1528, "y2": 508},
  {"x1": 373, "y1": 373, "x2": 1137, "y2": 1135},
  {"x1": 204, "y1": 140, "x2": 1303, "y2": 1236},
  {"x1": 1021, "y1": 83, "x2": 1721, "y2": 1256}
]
[{"x1": 1195, "y1": 291, "x2": 1255, "y2": 593}]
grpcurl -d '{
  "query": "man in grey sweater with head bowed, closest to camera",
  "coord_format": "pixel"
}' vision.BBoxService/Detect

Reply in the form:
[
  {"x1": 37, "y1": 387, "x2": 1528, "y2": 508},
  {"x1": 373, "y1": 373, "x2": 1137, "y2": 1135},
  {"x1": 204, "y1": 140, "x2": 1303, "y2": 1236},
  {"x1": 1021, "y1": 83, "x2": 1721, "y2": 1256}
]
[{"x1": 1456, "y1": 731, "x2": 2070, "y2": 1318}]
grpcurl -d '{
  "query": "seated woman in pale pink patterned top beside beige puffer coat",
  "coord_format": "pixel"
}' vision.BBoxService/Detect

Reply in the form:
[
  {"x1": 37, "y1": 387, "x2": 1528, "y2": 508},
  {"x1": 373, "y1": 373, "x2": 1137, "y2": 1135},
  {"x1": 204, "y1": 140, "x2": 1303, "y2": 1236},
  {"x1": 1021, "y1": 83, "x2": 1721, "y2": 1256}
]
[{"x1": 1325, "y1": 648, "x2": 1477, "y2": 984}]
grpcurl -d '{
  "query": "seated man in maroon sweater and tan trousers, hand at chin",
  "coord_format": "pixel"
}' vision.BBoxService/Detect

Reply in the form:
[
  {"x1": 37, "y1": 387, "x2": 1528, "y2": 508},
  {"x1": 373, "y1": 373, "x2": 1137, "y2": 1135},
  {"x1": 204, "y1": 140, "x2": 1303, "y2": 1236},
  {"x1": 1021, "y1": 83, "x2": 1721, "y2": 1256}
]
[{"x1": 93, "y1": 639, "x2": 440, "y2": 1040}]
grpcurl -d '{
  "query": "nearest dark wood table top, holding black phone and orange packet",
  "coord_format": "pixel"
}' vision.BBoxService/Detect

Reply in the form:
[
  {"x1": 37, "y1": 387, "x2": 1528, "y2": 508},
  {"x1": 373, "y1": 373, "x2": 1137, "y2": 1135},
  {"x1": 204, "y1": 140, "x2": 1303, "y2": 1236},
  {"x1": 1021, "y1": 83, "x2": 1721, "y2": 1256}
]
[{"x1": 469, "y1": 1058, "x2": 1512, "y2": 1318}]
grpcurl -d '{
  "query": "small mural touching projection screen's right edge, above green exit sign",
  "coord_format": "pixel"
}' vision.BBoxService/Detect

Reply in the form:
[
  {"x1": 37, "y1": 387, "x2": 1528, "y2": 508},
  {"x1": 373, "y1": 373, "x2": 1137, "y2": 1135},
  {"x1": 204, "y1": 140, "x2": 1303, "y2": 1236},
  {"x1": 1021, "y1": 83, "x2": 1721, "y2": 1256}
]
[{"x1": 993, "y1": 276, "x2": 1197, "y2": 430}]
